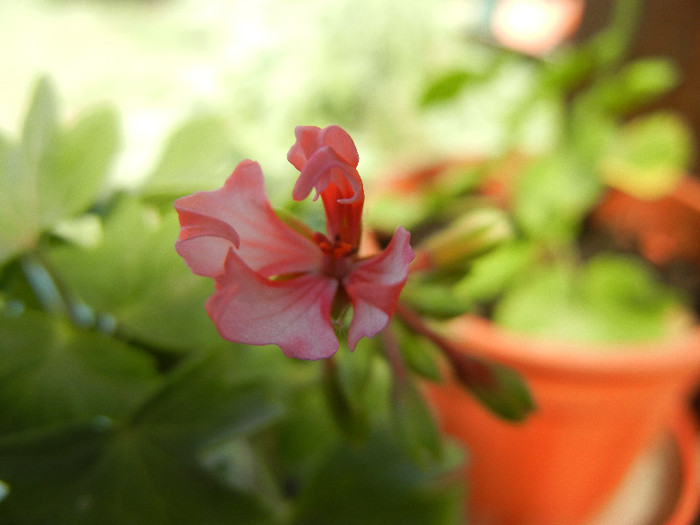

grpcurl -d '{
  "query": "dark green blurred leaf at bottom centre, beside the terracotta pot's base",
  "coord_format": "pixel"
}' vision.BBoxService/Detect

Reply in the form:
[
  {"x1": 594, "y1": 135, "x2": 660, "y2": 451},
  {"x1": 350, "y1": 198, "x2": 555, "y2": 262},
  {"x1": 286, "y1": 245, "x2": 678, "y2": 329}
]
[{"x1": 292, "y1": 432, "x2": 464, "y2": 525}]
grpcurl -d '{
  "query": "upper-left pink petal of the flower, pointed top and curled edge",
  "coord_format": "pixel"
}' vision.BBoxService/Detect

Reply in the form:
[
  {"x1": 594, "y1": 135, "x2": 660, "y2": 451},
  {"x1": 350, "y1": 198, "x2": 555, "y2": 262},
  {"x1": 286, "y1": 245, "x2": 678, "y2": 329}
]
[{"x1": 175, "y1": 160, "x2": 322, "y2": 277}]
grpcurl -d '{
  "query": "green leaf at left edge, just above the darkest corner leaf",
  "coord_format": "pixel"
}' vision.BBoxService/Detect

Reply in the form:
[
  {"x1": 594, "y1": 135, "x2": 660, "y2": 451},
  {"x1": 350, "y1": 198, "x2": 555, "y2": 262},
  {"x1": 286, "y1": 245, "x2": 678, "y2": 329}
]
[{"x1": 0, "y1": 311, "x2": 156, "y2": 433}]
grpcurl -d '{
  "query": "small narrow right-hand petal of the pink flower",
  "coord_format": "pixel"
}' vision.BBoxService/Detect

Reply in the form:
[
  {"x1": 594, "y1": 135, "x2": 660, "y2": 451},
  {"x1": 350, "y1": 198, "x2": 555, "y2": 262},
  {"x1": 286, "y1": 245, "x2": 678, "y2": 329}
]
[{"x1": 343, "y1": 227, "x2": 414, "y2": 349}]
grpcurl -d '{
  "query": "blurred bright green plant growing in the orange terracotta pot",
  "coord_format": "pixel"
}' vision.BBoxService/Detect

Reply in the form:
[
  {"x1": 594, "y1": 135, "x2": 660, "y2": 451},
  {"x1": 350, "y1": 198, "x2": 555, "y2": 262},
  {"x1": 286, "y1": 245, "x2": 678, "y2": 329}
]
[{"x1": 386, "y1": 0, "x2": 694, "y2": 343}]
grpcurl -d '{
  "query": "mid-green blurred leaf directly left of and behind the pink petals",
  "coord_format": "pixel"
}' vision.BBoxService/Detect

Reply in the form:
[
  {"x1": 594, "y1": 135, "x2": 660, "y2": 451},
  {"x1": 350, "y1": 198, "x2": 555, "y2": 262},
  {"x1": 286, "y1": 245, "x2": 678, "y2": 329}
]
[{"x1": 49, "y1": 198, "x2": 221, "y2": 352}]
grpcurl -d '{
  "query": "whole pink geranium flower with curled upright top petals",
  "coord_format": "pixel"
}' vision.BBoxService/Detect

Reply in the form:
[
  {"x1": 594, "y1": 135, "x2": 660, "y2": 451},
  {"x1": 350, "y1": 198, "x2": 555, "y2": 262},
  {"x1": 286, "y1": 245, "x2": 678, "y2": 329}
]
[{"x1": 175, "y1": 126, "x2": 414, "y2": 359}]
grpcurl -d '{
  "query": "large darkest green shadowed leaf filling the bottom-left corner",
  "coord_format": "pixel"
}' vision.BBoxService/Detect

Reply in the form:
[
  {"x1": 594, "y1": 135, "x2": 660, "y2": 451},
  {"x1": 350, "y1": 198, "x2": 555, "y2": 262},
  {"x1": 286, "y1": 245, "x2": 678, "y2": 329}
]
[{"x1": 0, "y1": 346, "x2": 286, "y2": 525}]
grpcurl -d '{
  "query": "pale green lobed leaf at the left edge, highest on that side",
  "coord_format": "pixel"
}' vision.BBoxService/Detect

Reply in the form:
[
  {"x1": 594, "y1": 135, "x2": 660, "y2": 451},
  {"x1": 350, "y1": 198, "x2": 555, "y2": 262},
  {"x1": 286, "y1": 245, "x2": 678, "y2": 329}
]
[{"x1": 0, "y1": 80, "x2": 118, "y2": 263}]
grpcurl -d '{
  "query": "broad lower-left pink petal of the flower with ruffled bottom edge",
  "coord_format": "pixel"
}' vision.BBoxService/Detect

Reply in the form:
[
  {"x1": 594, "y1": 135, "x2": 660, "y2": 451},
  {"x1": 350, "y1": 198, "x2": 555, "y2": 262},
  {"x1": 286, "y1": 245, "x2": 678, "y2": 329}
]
[{"x1": 206, "y1": 248, "x2": 338, "y2": 359}]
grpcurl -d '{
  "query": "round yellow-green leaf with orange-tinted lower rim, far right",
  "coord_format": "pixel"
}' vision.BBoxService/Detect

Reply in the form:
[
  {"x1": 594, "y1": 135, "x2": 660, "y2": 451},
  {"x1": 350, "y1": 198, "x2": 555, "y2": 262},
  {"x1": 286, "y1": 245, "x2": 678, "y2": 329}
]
[{"x1": 601, "y1": 112, "x2": 693, "y2": 199}]
